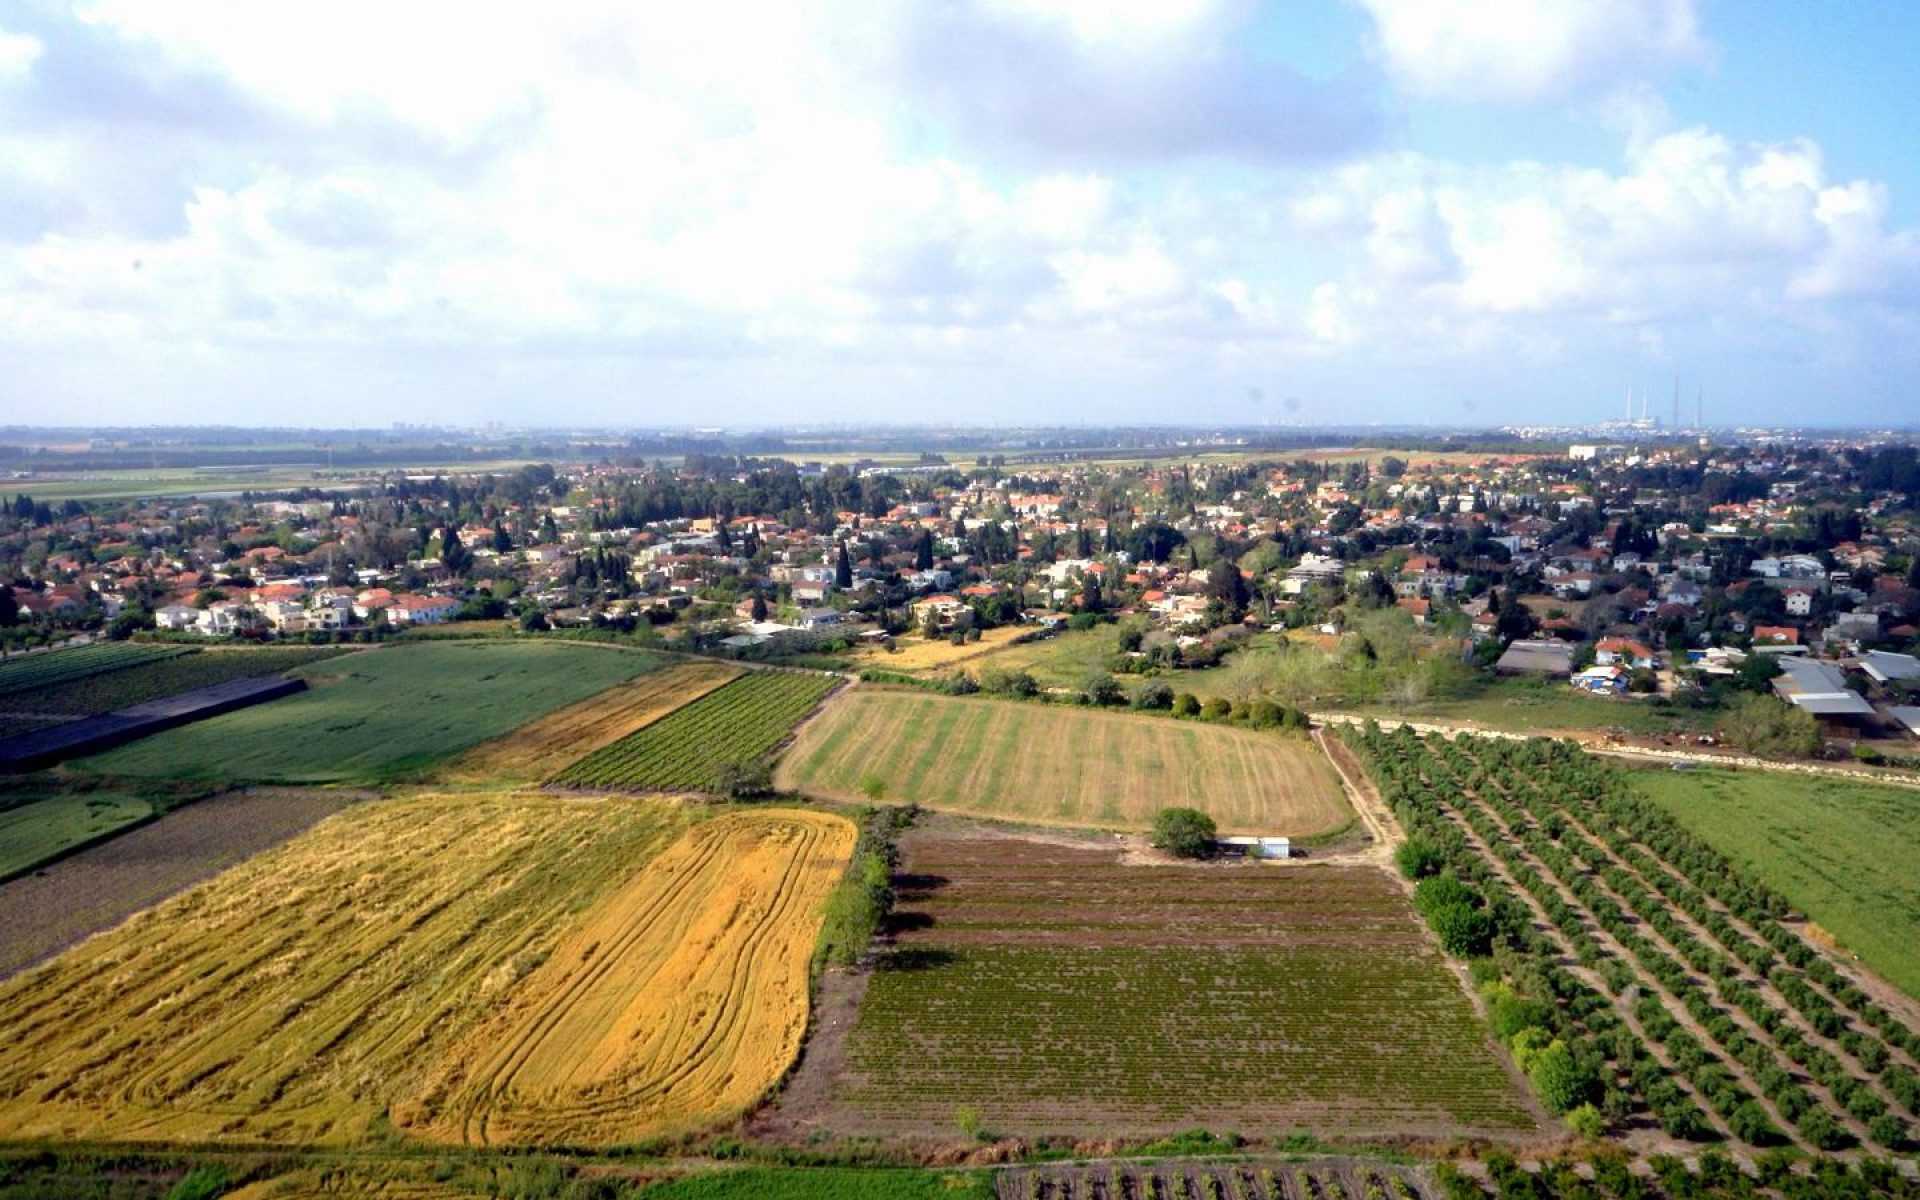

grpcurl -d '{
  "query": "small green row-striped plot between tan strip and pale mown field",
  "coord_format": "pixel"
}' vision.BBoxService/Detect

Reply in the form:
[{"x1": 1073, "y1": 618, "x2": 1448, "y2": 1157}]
[{"x1": 553, "y1": 670, "x2": 839, "y2": 791}]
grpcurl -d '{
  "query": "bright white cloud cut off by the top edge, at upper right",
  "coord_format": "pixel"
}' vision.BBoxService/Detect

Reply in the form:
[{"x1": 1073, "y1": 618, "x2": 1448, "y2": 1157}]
[{"x1": 1357, "y1": 0, "x2": 1707, "y2": 104}]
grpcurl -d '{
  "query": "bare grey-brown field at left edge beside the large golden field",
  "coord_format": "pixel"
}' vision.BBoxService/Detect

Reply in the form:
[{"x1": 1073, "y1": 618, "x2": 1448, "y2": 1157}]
[{"x1": 0, "y1": 791, "x2": 353, "y2": 977}]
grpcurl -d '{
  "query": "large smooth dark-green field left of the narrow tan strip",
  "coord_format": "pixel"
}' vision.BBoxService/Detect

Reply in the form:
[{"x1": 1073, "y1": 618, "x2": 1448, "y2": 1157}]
[{"x1": 77, "y1": 641, "x2": 660, "y2": 783}]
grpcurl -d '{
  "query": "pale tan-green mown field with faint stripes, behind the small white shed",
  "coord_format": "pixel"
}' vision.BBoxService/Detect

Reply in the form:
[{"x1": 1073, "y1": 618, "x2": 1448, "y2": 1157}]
[{"x1": 778, "y1": 687, "x2": 1354, "y2": 837}]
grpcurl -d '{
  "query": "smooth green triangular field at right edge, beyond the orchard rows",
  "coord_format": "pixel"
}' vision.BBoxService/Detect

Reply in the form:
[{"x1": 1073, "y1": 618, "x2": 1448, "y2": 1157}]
[{"x1": 1634, "y1": 770, "x2": 1920, "y2": 996}]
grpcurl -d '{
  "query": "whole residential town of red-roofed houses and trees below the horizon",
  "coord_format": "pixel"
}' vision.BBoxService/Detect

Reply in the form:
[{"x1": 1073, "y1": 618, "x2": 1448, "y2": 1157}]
[{"x1": 0, "y1": 438, "x2": 1920, "y2": 751}]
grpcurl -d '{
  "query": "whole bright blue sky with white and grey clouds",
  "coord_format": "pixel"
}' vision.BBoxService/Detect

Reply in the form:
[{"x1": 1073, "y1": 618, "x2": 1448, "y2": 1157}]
[{"x1": 0, "y1": 0, "x2": 1920, "y2": 424}]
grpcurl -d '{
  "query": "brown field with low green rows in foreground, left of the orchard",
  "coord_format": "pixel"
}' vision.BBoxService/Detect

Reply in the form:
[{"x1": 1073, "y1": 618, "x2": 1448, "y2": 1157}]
[{"x1": 770, "y1": 829, "x2": 1536, "y2": 1137}]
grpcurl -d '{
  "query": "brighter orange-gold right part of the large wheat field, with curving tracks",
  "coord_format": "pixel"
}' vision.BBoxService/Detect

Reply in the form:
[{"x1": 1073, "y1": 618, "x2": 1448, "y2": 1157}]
[{"x1": 394, "y1": 810, "x2": 854, "y2": 1144}]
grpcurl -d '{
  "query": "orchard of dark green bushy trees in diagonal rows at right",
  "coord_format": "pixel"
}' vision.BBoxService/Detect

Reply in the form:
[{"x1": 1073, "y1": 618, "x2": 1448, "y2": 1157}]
[{"x1": 1346, "y1": 728, "x2": 1920, "y2": 1152}]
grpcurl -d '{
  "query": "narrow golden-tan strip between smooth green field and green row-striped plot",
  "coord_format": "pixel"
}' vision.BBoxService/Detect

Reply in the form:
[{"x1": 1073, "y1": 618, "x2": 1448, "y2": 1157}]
[{"x1": 444, "y1": 662, "x2": 741, "y2": 785}]
